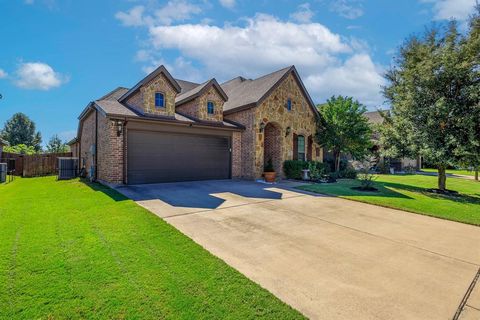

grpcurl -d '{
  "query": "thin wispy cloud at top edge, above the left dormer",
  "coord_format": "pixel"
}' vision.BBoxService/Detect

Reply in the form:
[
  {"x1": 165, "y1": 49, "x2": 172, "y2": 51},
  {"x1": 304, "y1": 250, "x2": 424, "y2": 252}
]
[{"x1": 115, "y1": 0, "x2": 202, "y2": 27}]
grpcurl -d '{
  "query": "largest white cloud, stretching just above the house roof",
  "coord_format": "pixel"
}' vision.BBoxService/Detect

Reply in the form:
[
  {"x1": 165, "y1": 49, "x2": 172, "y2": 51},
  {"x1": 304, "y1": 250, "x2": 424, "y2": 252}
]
[{"x1": 141, "y1": 14, "x2": 384, "y2": 106}]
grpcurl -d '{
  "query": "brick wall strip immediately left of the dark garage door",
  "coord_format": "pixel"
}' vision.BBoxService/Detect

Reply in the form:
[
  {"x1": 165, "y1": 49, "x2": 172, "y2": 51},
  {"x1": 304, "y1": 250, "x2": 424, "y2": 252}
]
[{"x1": 97, "y1": 115, "x2": 126, "y2": 184}]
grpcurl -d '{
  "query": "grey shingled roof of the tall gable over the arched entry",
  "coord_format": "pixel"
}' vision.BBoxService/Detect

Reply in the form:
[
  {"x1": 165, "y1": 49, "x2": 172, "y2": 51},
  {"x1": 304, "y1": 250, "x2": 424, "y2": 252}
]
[{"x1": 221, "y1": 66, "x2": 318, "y2": 115}]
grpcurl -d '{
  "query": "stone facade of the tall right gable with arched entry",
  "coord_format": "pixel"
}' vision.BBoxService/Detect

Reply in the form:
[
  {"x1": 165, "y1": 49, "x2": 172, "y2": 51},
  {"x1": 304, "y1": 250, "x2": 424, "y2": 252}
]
[{"x1": 225, "y1": 73, "x2": 323, "y2": 179}]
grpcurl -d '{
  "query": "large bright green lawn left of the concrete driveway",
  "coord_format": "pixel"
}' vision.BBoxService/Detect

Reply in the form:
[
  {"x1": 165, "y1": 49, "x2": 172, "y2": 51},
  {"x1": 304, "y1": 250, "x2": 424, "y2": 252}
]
[{"x1": 0, "y1": 177, "x2": 303, "y2": 319}]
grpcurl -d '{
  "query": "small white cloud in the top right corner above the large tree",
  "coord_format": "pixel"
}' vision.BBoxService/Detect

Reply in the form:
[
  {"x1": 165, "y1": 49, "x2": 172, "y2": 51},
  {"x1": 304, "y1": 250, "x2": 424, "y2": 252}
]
[{"x1": 421, "y1": 0, "x2": 476, "y2": 21}]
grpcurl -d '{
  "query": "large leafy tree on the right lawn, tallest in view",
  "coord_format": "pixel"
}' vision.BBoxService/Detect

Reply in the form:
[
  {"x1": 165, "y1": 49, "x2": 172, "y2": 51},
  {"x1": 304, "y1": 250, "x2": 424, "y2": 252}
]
[{"x1": 382, "y1": 14, "x2": 478, "y2": 191}]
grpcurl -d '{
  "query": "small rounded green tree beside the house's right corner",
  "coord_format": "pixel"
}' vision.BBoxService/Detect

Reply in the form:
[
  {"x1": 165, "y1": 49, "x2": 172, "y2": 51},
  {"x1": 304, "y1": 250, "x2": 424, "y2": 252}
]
[{"x1": 316, "y1": 96, "x2": 372, "y2": 172}]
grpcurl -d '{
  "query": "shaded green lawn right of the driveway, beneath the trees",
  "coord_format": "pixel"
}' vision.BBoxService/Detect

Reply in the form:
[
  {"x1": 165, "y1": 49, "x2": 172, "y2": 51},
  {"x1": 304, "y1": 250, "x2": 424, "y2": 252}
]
[{"x1": 300, "y1": 175, "x2": 480, "y2": 225}]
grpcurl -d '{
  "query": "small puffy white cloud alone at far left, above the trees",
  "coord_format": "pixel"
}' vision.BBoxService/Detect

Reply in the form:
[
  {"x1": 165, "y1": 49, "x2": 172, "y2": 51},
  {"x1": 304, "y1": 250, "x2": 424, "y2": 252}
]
[{"x1": 14, "y1": 62, "x2": 68, "y2": 90}]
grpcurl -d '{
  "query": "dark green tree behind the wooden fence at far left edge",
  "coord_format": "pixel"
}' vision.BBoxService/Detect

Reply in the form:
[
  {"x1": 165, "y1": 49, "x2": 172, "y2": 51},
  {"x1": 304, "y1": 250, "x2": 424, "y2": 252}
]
[{"x1": 0, "y1": 112, "x2": 42, "y2": 151}]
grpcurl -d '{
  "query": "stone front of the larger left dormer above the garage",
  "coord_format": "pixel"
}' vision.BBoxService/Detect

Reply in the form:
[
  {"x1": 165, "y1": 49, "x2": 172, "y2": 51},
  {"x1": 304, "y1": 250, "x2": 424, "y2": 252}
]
[{"x1": 126, "y1": 74, "x2": 177, "y2": 117}]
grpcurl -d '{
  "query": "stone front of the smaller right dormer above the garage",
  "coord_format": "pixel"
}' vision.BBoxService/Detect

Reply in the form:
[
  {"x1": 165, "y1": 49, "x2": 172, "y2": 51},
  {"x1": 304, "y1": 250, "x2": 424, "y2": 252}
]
[{"x1": 176, "y1": 85, "x2": 225, "y2": 122}]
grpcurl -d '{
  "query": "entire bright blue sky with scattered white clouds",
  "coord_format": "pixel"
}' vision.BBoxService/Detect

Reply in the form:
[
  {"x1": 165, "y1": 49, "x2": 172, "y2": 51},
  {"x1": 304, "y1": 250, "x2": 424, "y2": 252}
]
[{"x1": 0, "y1": 0, "x2": 475, "y2": 144}]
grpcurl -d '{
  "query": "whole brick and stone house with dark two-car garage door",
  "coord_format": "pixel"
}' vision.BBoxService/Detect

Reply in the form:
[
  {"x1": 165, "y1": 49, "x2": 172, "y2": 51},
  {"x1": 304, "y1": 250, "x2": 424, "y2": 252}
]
[{"x1": 69, "y1": 66, "x2": 322, "y2": 184}]
